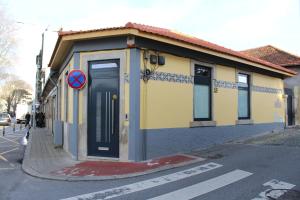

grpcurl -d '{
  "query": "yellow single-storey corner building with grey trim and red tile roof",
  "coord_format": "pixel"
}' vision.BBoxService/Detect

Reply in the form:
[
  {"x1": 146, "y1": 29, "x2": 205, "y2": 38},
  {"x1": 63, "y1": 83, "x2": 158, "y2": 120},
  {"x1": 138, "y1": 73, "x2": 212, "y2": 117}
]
[{"x1": 43, "y1": 23, "x2": 295, "y2": 161}]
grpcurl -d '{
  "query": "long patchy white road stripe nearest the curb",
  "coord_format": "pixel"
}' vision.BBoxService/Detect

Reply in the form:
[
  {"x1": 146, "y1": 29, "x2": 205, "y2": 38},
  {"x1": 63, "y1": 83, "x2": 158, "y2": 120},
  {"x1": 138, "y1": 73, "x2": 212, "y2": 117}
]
[{"x1": 63, "y1": 162, "x2": 223, "y2": 200}]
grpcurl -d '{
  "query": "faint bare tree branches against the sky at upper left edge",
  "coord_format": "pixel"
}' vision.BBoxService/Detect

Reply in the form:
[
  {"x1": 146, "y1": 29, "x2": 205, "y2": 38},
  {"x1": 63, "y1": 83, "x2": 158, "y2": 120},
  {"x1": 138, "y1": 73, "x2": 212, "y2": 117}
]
[{"x1": 0, "y1": 4, "x2": 16, "y2": 74}]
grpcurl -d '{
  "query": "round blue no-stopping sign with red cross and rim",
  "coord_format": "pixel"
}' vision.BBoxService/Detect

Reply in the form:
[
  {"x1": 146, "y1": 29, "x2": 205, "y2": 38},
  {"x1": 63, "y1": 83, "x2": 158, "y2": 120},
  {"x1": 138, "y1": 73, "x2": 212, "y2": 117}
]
[{"x1": 67, "y1": 69, "x2": 86, "y2": 90}]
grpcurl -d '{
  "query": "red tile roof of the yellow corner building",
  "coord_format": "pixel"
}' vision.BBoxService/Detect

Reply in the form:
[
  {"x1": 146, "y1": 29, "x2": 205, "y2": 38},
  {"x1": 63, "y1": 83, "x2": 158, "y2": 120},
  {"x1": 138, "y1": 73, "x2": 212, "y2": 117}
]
[{"x1": 59, "y1": 22, "x2": 296, "y2": 74}]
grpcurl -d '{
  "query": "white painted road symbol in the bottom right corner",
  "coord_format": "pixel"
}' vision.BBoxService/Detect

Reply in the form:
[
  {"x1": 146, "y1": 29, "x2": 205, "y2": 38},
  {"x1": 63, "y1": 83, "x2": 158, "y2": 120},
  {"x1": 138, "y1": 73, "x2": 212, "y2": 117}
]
[{"x1": 252, "y1": 179, "x2": 296, "y2": 200}]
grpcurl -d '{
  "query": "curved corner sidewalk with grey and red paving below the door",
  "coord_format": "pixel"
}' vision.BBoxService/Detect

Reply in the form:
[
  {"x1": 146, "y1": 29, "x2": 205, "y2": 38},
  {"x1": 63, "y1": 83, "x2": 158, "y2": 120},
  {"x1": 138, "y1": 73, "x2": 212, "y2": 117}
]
[{"x1": 22, "y1": 128, "x2": 203, "y2": 181}]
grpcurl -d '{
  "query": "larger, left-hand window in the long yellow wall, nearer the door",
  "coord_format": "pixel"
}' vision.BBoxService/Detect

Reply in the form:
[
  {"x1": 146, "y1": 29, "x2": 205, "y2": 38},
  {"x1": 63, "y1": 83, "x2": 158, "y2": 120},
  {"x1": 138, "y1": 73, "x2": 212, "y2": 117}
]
[{"x1": 194, "y1": 65, "x2": 211, "y2": 121}]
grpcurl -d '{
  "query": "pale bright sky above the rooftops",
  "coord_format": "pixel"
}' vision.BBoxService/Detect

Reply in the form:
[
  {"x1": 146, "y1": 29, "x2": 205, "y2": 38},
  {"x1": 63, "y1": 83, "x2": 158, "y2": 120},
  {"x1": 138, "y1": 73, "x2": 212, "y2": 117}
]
[{"x1": 0, "y1": 0, "x2": 300, "y2": 86}]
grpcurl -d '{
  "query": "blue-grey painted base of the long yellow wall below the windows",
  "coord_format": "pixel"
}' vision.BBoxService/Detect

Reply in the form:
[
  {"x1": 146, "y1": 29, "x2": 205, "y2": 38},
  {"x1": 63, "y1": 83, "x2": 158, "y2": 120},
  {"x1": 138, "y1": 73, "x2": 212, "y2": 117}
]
[{"x1": 141, "y1": 123, "x2": 284, "y2": 159}]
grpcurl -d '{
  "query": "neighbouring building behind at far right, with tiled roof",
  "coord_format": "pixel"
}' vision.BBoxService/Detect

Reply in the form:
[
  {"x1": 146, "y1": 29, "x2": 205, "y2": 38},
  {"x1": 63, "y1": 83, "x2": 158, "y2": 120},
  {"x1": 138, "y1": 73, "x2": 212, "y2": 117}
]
[{"x1": 242, "y1": 45, "x2": 300, "y2": 126}]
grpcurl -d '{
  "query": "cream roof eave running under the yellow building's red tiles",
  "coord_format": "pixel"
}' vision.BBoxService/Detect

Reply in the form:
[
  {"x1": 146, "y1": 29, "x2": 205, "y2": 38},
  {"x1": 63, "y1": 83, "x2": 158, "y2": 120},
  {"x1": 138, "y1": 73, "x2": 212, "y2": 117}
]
[{"x1": 49, "y1": 27, "x2": 297, "y2": 77}]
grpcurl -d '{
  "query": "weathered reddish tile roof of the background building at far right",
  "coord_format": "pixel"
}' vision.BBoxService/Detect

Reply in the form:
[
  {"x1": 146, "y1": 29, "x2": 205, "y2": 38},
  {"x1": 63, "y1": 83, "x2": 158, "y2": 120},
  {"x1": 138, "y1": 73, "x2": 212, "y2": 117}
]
[{"x1": 241, "y1": 45, "x2": 300, "y2": 66}]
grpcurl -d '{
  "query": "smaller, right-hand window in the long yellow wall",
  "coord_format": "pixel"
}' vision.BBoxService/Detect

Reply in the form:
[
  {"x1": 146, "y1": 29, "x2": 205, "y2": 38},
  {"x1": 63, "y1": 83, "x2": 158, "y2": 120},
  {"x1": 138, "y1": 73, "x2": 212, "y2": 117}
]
[{"x1": 238, "y1": 73, "x2": 250, "y2": 119}]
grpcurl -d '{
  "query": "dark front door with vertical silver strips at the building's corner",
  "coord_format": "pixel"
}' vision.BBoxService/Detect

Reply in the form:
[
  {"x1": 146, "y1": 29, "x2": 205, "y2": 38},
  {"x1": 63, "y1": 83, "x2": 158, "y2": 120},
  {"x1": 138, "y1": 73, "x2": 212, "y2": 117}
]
[{"x1": 88, "y1": 60, "x2": 119, "y2": 157}]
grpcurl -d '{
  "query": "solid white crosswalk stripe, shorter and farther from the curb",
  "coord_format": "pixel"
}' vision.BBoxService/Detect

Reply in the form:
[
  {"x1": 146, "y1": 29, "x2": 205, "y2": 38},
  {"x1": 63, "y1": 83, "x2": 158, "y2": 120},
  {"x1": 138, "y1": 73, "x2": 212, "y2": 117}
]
[{"x1": 149, "y1": 169, "x2": 252, "y2": 200}]
